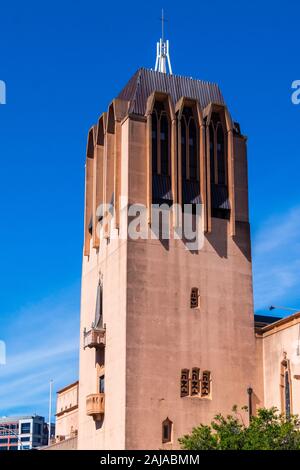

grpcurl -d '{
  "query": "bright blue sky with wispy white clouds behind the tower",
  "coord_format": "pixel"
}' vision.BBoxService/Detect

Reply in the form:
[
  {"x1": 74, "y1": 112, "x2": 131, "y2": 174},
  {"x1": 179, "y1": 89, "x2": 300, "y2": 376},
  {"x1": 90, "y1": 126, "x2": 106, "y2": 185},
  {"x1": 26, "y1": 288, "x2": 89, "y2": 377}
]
[{"x1": 0, "y1": 0, "x2": 300, "y2": 415}]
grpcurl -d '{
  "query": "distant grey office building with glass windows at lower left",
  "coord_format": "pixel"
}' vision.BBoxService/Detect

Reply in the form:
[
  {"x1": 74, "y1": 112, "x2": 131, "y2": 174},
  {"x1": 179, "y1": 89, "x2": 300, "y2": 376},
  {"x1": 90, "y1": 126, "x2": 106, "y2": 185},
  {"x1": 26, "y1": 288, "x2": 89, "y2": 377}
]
[{"x1": 0, "y1": 415, "x2": 54, "y2": 451}]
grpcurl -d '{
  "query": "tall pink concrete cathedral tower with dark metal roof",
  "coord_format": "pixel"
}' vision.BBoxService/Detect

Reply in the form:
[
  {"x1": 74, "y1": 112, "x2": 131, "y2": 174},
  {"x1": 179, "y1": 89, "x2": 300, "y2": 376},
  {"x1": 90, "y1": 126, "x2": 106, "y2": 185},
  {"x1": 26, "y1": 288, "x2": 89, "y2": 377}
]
[{"x1": 78, "y1": 69, "x2": 262, "y2": 449}]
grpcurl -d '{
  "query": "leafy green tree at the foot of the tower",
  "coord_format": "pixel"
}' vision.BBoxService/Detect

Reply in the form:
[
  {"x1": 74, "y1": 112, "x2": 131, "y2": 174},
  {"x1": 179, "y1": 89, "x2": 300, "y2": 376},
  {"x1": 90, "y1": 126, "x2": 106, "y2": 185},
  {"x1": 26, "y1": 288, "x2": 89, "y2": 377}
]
[{"x1": 179, "y1": 407, "x2": 300, "y2": 450}]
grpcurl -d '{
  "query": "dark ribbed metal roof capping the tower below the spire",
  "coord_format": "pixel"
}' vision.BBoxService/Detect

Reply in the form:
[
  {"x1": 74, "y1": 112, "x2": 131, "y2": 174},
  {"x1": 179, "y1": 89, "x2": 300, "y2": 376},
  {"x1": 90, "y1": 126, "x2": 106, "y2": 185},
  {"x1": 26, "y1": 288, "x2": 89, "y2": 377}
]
[{"x1": 117, "y1": 68, "x2": 225, "y2": 115}]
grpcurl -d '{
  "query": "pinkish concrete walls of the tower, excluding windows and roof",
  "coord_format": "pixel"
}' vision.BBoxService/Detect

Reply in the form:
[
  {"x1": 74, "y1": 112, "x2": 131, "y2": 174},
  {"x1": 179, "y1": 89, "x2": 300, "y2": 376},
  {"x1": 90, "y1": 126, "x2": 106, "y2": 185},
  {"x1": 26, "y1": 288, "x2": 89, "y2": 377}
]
[{"x1": 78, "y1": 72, "x2": 263, "y2": 449}]
